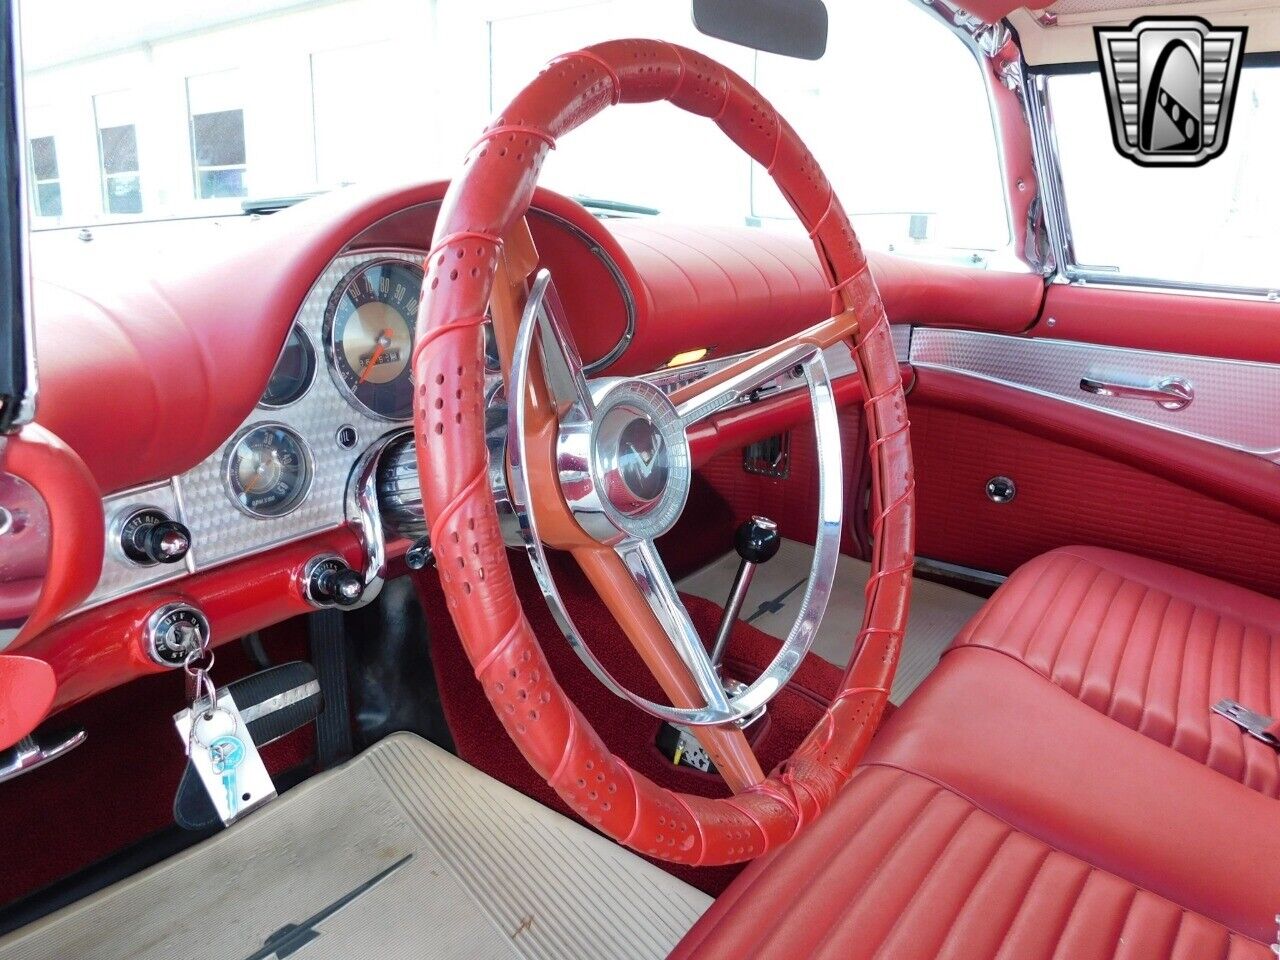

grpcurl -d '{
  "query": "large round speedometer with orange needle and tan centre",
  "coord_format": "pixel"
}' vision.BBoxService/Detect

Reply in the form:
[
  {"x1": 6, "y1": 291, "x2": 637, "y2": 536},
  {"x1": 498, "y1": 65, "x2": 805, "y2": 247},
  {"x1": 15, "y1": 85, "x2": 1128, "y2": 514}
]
[{"x1": 324, "y1": 260, "x2": 422, "y2": 420}]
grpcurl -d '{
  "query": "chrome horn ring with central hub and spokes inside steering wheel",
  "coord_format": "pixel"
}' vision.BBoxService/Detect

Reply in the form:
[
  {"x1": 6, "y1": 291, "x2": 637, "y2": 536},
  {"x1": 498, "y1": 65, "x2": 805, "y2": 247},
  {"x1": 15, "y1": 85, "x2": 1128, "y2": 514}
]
[{"x1": 507, "y1": 269, "x2": 844, "y2": 727}]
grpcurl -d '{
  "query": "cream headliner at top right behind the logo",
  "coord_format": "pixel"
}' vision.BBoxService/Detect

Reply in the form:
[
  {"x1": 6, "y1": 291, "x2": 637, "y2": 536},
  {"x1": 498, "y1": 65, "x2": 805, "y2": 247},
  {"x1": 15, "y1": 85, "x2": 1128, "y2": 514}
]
[{"x1": 1009, "y1": 0, "x2": 1280, "y2": 67}]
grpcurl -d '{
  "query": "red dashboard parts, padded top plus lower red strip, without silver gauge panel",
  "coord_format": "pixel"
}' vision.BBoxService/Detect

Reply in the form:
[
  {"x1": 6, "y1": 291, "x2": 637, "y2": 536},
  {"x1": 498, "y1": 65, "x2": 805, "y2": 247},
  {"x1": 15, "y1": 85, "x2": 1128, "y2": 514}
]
[{"x1": 18, "y1": 183, "x2": 1043, "y2": 709}]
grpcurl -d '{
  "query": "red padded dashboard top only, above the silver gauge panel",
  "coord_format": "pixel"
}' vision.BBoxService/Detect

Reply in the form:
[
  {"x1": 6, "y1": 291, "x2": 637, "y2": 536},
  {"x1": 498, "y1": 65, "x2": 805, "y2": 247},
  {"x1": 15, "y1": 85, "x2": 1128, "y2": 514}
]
[{"x1": 35, "y1": 182, "x2": 1043, "y2": 504}]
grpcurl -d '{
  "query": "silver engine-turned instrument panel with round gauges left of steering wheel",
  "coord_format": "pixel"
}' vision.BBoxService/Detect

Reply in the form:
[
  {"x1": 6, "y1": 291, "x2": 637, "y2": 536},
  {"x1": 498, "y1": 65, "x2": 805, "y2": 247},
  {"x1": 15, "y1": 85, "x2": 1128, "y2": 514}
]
[{"x1": 81, "y1": 250, "x2": 422, "y2": 609}]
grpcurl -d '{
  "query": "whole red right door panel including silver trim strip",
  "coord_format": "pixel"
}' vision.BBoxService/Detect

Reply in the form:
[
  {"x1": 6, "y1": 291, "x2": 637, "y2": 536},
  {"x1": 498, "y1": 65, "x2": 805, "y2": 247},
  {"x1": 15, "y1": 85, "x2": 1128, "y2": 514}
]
[{"x1": 909, "y1": 284, "x2": 1280, "y2": 594}]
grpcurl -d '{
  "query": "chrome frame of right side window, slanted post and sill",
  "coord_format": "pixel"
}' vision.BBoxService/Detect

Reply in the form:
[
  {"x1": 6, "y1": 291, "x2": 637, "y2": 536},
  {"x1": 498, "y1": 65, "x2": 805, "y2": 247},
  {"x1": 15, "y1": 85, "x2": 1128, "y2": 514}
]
[{"x1": 1014, "y1": 61, "x2": 1280, "y2": 303}]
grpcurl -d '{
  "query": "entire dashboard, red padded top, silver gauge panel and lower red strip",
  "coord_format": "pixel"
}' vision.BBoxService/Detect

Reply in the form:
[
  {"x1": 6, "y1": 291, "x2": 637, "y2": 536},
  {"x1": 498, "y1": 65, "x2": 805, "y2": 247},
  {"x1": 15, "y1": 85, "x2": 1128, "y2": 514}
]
[{"x1": 0, "y1": 183, "x2": 1018, "y2": 709}]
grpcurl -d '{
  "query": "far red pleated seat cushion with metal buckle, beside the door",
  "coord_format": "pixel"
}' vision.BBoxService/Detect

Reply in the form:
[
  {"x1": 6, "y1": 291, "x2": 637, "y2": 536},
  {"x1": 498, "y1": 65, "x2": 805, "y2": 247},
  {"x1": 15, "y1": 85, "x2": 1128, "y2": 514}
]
[{"x1": 956, "y1": 547, "x2": 1280, "y2": 797}]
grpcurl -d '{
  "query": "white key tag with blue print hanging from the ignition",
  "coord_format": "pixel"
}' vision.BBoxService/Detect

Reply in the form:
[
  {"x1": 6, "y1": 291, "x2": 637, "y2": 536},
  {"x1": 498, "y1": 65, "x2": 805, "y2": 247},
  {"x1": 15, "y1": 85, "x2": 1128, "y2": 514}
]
[{"x1": 173, "y1": 689, "x2": 275, "y2": 826}]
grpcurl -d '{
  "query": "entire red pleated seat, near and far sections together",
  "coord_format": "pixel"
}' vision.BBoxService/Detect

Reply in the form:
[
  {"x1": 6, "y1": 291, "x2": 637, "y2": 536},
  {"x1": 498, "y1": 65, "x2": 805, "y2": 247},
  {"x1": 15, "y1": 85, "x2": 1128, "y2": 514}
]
[{"x1": 673, "y1": 548, "x2": 1280, "y2": 960}]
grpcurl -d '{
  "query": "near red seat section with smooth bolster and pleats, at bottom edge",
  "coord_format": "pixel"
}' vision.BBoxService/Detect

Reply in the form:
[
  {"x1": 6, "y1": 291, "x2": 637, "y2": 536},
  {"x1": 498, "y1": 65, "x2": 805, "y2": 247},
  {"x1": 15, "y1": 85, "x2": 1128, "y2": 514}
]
[{"x1": 673, "y1": 648, "x2": 1280, "y2": 960}]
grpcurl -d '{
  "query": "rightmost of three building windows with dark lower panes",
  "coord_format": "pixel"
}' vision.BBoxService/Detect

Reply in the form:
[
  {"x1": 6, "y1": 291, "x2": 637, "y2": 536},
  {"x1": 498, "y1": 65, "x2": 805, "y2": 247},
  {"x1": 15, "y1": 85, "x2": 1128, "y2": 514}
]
[{"x1": 187, "y1": 72, "x2": 247, "y2": 200}]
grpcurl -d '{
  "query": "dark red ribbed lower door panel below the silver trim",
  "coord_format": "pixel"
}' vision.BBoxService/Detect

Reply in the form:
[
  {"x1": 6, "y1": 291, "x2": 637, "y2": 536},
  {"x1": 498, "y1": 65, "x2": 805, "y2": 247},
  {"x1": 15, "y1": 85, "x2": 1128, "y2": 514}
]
[{"x1": 911, "y1": 399, "x2": 1280, "y2": 594}]
